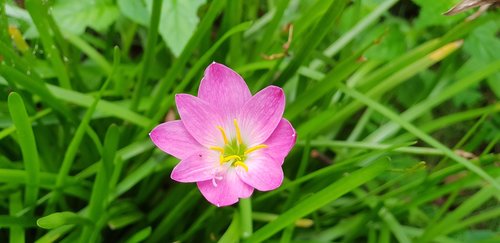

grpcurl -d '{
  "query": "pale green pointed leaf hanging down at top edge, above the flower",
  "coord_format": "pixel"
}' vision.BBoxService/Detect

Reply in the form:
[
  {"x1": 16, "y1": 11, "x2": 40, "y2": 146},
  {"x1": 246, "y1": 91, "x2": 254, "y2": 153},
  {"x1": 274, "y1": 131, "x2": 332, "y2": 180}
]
[{"x1": 146, "y1": 0, "x2": 205, "y2": 57}]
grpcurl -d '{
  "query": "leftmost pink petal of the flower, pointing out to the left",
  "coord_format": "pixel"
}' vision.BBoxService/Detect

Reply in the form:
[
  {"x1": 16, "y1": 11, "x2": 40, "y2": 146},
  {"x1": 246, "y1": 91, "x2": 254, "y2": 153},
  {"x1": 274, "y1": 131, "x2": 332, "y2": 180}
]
[{"x1": 149, "y1": 121, "x2": 203, "y2": 159}]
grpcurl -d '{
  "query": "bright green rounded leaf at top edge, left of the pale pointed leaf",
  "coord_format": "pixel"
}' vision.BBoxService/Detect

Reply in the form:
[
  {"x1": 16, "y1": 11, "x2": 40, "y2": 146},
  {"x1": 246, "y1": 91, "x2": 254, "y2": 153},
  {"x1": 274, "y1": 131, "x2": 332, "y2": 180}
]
[{"x1": 52, "y1": 0, "x2": 119, "y2": 35}]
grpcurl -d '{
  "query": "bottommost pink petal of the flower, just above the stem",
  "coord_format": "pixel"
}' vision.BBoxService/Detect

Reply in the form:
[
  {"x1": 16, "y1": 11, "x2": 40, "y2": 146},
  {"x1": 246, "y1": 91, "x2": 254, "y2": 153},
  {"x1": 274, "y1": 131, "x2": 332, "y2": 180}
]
[{"x1": 197, "y1": 168, "x2": 253, "y2": 207}]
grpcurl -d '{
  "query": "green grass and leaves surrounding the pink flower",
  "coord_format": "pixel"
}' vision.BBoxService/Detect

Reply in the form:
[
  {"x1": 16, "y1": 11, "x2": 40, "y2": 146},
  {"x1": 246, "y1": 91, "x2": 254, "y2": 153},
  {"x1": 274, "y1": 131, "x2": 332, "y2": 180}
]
[{"x1": 0, "y1": 0, "x2": 500, "y2": 242}]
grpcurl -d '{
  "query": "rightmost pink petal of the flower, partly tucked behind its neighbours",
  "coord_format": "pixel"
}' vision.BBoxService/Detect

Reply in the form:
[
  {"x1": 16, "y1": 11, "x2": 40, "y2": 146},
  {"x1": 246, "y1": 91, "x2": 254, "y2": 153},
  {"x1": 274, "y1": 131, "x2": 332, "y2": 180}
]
[{"x1": 264, "y1": 118, "x2": 297, "y2": 164}]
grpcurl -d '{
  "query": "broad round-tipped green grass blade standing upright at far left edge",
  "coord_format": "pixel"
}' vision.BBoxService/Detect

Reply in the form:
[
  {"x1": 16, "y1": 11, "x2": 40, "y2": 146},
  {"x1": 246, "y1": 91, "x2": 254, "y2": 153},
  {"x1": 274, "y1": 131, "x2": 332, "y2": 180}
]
[{"x1": 8, "y1": 92, "x2": 40, "y2": 210}]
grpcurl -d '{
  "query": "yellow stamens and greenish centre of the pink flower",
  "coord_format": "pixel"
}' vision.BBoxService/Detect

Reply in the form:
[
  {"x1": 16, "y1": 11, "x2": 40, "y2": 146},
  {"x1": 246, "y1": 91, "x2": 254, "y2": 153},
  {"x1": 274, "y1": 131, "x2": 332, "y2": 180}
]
[{"x1": 210, "y1": 119, "x2": 267, "y2": 171}]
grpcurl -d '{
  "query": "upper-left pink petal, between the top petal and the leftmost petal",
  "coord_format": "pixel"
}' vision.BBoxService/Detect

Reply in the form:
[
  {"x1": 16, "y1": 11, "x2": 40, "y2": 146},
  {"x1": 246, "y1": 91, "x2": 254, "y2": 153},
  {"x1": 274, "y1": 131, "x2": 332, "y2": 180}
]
[{"x1": 175, "y1": 94, "x2": 224, "y2": 147}]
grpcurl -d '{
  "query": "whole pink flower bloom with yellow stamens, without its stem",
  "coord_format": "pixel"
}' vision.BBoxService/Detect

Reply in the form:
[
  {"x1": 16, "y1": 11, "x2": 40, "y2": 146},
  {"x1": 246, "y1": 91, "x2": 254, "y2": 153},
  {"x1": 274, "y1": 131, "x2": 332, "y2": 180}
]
[{"x1": 150, "y1": 62, "x2": 296, "y2": 207}]
